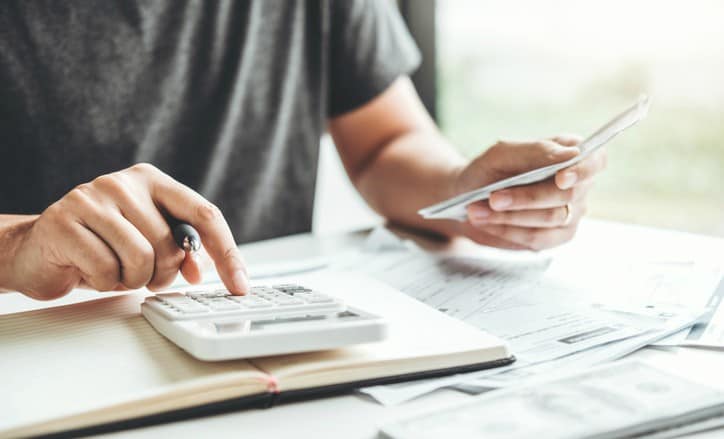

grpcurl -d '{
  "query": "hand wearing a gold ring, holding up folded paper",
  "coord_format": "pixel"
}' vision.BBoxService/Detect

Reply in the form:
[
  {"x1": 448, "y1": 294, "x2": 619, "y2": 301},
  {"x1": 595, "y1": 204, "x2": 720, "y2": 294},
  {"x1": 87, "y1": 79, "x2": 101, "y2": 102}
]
[{"x1": 456, "y1": 136, "x2": 606, "y2": 250}]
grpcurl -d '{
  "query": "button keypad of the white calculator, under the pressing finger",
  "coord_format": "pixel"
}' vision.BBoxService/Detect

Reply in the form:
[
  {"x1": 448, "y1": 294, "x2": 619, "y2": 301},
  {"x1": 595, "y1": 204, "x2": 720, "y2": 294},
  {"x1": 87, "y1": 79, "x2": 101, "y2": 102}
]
[{"x1": 145, "y1": 284, "x2": 346, "y2": 321}]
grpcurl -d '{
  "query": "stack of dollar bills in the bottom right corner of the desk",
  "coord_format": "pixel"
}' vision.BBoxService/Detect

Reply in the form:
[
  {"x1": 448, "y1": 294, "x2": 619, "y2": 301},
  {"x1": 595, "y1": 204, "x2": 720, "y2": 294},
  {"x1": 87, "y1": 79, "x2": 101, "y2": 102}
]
[{"x1": 381, "y1": 362, "x2": 724, "y2": 439}]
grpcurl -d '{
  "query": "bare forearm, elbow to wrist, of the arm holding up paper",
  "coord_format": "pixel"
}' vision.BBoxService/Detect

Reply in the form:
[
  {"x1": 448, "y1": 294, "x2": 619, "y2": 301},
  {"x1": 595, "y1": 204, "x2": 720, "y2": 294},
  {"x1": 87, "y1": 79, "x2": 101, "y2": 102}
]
[{"x1": 354, "y1": 129, "x2": 466, "y2": 236}]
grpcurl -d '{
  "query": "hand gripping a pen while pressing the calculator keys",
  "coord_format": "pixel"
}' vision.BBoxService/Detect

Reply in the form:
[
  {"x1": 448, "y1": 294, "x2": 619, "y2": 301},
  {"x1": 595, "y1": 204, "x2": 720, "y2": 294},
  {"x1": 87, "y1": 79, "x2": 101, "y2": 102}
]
[{"x1": 0, "y1": 164, "x2": 248, "y2": 299}]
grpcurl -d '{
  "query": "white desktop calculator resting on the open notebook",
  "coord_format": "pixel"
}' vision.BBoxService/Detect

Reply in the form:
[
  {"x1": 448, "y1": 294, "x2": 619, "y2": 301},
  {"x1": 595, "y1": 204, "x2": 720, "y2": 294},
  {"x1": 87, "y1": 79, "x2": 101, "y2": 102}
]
[{"x1": 141, "y1": 284, "x2": 387, "y2": 361}]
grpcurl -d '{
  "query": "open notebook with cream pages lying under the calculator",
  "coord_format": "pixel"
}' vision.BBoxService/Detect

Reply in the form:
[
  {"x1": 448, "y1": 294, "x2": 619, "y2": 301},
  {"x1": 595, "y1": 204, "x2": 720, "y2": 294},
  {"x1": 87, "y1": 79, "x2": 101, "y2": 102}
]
[{"x1": 0, "y1": 273, "x2": 513, "y2": 437}]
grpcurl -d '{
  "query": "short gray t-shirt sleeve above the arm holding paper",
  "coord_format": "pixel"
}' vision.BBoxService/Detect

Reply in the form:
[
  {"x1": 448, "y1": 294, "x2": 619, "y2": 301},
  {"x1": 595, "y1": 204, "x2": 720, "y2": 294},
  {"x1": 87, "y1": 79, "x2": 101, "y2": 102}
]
[{"x1": 328, "y1": 0, "x2": 421, "y2": 117}]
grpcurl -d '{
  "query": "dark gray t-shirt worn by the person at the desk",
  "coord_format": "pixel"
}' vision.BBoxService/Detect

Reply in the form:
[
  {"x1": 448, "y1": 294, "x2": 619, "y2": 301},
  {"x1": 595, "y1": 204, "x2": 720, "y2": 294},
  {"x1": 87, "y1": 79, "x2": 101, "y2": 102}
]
[{"x1": 0, "y1": 0, "x2": 419, "y2": 242}]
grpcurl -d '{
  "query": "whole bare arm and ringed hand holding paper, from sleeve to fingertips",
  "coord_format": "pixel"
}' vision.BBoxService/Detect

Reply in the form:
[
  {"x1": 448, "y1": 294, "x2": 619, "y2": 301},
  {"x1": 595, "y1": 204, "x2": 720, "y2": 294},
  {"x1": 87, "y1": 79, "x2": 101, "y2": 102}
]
[{"x1": 329, "y1": 78, "x2": 606, "y2": 250}]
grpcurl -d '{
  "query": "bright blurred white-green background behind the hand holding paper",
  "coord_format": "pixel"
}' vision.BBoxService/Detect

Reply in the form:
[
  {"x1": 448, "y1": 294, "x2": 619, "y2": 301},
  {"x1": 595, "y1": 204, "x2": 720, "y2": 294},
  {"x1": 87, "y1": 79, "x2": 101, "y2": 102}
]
[{"x1": 314, "y1": 0, "x2": 724, "y2": 236}]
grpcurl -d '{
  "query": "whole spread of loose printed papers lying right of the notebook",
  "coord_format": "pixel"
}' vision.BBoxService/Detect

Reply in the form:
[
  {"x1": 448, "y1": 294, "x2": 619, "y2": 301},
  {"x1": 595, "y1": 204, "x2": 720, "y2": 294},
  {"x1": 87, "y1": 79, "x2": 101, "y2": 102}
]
[{"x1": 336, "y1": 236, "x2": 714, "y2": 405}]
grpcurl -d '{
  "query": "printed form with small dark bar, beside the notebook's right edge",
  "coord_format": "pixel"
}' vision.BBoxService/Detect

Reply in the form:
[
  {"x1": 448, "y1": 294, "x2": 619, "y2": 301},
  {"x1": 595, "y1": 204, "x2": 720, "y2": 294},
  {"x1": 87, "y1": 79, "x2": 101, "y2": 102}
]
[{"x1": 336, "y1": 250, "x2": 680, "y2": 363}]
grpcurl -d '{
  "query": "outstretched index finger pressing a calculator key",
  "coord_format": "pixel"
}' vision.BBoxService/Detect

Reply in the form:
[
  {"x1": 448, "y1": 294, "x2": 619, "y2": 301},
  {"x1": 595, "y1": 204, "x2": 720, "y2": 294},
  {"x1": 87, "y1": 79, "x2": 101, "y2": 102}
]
[{"x1": 144, "y1": 171, "x2": 249, "y2": 294}]
